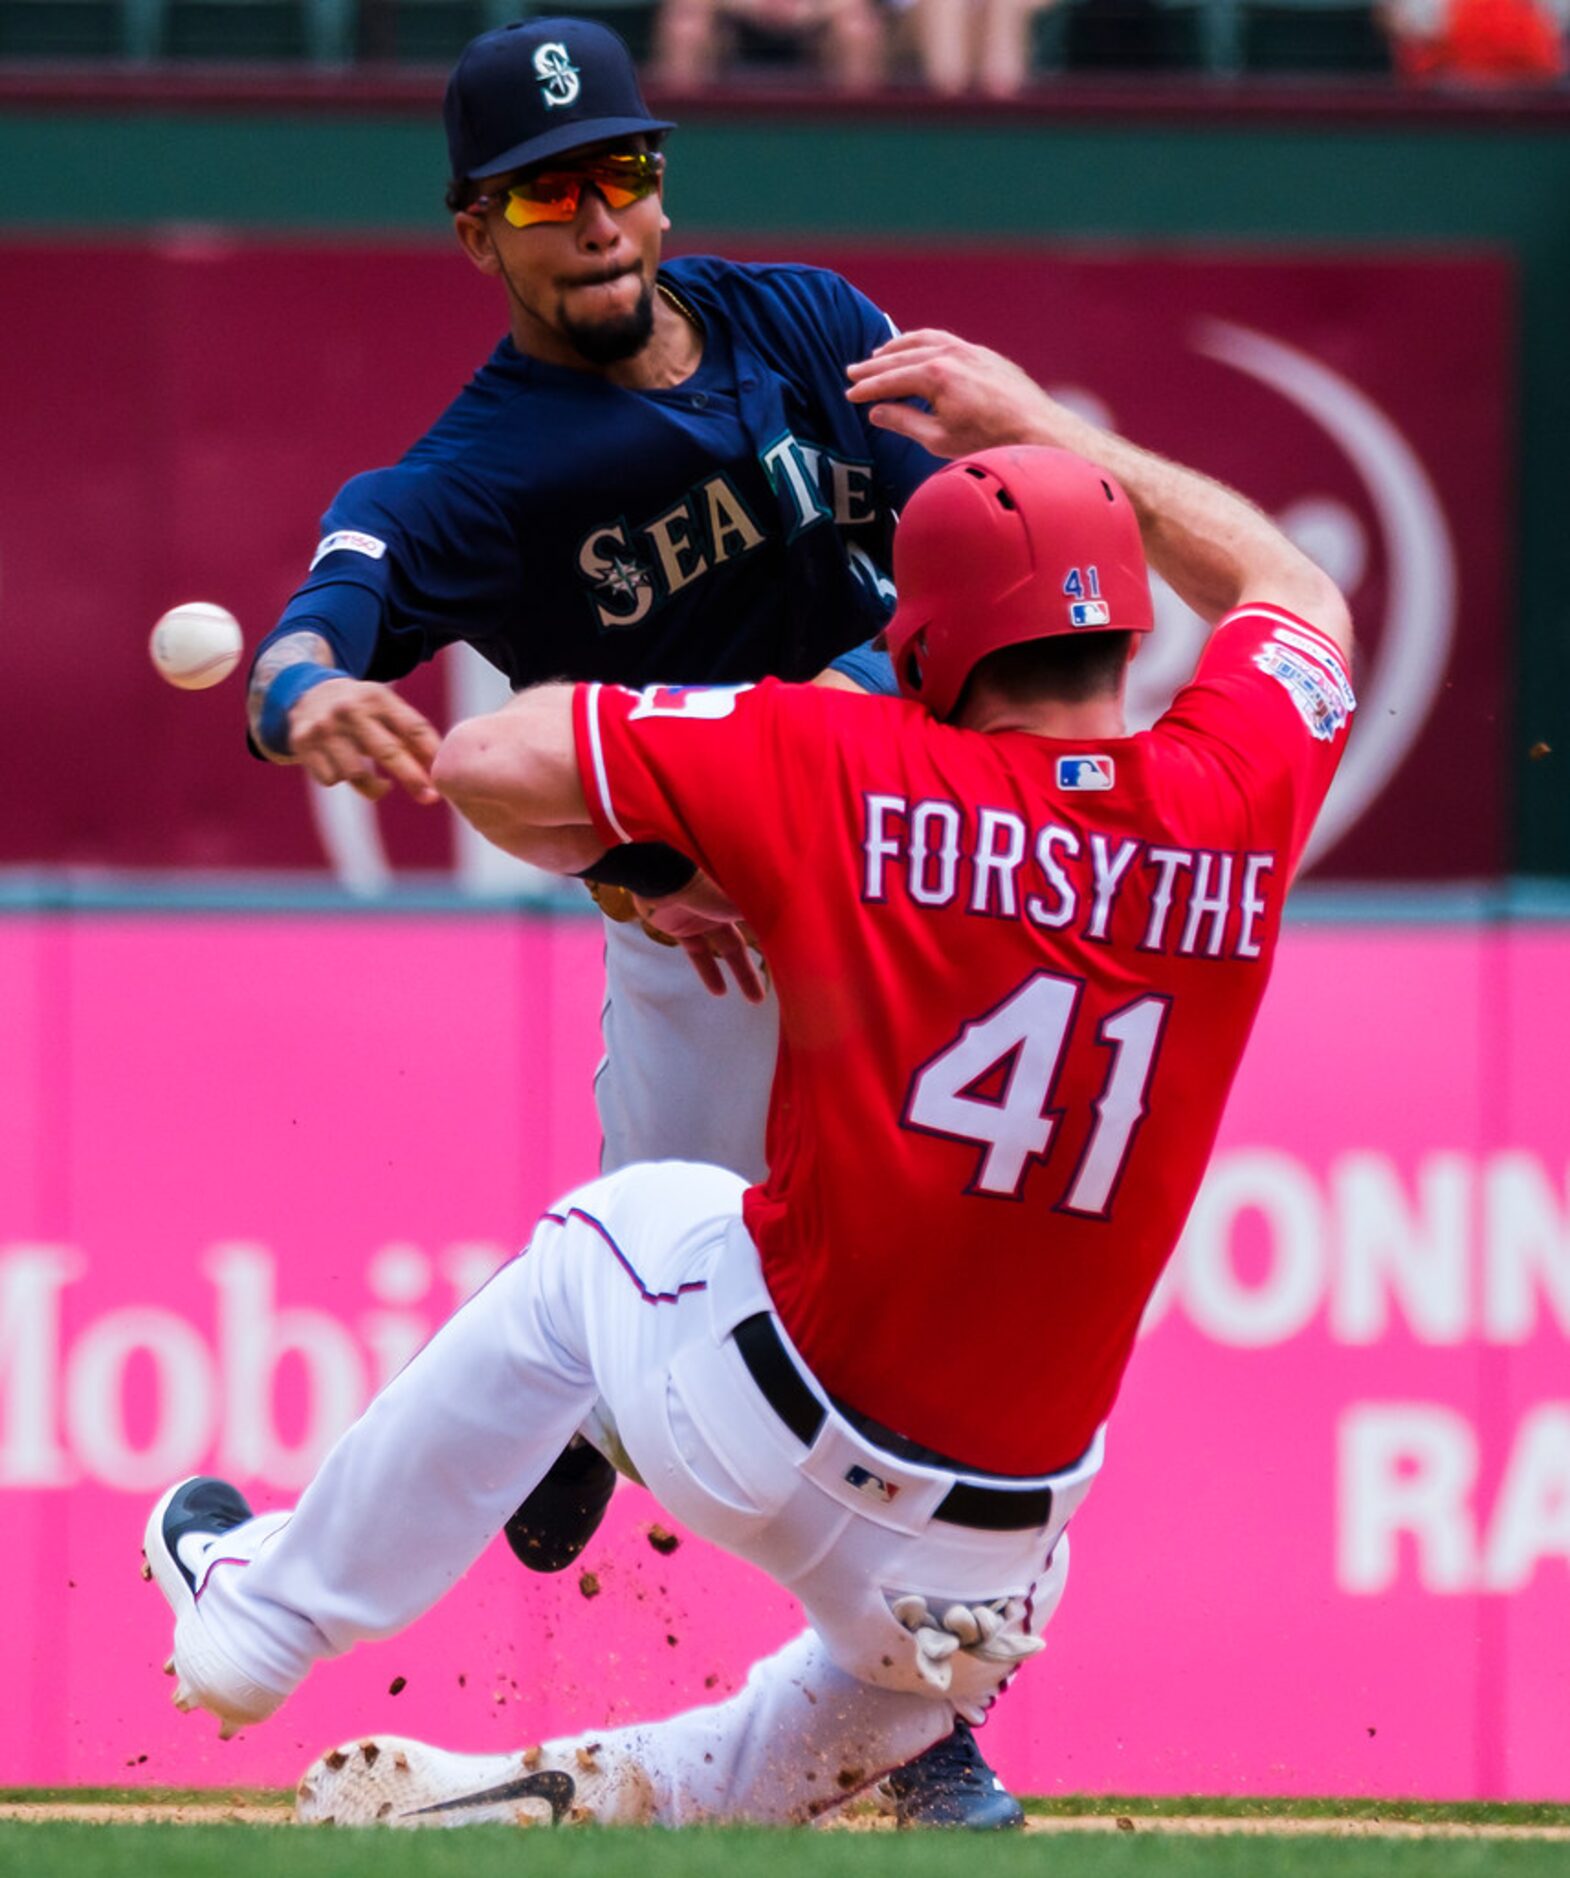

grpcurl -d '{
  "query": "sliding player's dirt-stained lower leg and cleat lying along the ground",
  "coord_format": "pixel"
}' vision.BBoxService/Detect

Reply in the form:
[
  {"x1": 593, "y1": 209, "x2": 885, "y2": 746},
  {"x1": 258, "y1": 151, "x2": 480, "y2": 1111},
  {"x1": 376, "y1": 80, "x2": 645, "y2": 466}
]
[{"x1": 295, "y1": 1632, "x2": 954, "y2": 1825}]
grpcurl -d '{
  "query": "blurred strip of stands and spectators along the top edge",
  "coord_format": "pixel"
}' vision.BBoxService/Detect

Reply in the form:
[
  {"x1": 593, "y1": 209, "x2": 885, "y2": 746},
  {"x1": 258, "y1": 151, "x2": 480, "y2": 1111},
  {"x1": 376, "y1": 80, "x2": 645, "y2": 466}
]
[{"x1": 0, "y1": 0, "x2": 1570, "y2": 98}]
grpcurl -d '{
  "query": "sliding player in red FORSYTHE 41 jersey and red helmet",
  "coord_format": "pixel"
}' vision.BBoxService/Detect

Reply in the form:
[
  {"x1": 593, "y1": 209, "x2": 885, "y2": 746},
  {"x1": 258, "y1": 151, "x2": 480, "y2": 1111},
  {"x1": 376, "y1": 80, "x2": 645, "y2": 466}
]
[{"x1": 146, "y1": 334, "x2": 1354, "y2": 1825}]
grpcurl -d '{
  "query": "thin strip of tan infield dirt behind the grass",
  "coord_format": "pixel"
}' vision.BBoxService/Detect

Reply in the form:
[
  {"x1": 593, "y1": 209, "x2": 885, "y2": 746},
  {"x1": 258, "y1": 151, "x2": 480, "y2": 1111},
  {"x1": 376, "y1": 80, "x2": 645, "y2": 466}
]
[{"x1": 0, "y1": 1797, "x2": 1570, "y2": 1842}]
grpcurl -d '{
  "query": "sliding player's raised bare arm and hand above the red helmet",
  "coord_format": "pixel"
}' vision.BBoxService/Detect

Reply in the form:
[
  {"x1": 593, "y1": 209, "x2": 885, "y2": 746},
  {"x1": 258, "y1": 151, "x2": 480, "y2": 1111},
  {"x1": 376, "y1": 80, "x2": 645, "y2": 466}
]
[{"x1": 849, "y1": 331, "x2": 1352, "y2": 652}]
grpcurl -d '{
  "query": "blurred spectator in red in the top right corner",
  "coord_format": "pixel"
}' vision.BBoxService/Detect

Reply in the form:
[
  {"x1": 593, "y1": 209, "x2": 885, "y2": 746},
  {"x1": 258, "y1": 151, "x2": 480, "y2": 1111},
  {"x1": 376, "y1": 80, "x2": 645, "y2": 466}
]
[{"x1": 1382, "y1": 0, "x2": 1570, "y2": 86}]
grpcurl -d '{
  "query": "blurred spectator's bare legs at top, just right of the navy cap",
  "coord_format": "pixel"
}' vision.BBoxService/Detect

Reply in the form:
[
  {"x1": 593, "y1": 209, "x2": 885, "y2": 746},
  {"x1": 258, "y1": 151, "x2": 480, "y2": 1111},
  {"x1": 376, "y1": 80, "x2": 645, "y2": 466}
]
[{"x1": 652, "y1": 0, "x2": 885, "y2": 92}]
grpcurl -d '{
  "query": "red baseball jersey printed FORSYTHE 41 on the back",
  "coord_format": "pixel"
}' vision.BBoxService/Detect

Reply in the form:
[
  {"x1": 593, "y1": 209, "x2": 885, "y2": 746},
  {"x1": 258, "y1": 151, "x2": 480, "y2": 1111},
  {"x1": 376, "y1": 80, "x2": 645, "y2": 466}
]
[{"x1": 575, "y1": 607, "x2": 1354, "y2": 1474}]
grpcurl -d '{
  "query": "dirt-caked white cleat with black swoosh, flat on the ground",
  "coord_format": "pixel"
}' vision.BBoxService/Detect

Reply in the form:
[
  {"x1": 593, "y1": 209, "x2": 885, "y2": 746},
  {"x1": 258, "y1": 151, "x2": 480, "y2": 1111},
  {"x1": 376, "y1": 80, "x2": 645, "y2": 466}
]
[{"x1": 295, "y1": 1735, "x2": 578, "y2": 1825}]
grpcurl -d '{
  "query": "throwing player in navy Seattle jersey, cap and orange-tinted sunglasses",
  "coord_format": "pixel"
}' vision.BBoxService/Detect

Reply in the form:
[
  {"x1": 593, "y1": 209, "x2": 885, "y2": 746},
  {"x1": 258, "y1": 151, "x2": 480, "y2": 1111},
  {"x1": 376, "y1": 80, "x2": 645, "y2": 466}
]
[{"x1": 235, "y1": 19, "x2": 1022, "y2": 1827}]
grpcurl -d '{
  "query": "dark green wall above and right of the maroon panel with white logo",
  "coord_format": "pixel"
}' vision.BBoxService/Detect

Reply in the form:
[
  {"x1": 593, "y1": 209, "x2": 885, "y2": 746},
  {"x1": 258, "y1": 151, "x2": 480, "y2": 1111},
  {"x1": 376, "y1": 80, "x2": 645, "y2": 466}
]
[{"x1": 0, "y1": 88, "x2": 1570, "y2": 875}]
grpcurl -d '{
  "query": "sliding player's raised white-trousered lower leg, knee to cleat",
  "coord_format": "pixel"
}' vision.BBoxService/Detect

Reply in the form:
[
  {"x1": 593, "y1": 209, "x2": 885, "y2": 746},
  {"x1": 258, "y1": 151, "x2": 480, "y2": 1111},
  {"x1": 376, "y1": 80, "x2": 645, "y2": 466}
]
[{"x1": 146, "y1": 1181, "x2": 676, "y2": 1722}]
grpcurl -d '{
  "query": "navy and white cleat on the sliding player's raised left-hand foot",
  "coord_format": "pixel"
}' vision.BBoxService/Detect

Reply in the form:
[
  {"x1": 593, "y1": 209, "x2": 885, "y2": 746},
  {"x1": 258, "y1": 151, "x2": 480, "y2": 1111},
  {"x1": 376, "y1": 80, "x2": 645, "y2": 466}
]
[{"x1": 143, "y1": 1474, "x2": 284, "y2": 1741}]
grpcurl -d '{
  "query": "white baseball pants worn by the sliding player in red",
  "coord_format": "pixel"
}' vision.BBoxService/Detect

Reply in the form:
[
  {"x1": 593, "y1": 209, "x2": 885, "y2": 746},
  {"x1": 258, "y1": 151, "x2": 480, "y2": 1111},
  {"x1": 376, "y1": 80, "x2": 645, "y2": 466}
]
[{"x1": 197, "y1": 1162, "x2": 1101, "y2": 1825}]
